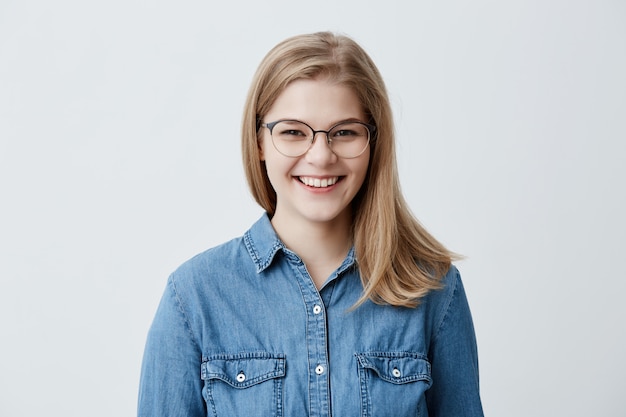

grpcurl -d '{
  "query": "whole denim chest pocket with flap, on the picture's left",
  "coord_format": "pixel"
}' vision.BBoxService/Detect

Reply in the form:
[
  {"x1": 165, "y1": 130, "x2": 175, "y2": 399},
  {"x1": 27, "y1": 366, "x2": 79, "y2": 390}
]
[{"x1": 201, "y1": 352, "x2": 286, "y2": 417}]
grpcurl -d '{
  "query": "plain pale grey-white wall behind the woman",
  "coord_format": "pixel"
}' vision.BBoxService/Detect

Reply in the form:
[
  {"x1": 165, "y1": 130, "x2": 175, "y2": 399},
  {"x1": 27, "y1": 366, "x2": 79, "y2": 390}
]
[{"x1": 0, "y1": 0, "x2": 626, "y2": 417}]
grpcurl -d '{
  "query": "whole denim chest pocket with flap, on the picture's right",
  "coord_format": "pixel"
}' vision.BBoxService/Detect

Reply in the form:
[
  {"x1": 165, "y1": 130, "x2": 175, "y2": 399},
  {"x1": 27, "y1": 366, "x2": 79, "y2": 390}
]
[{"x1": 356, "y1": 352, "x2": 432, "y2": 417}]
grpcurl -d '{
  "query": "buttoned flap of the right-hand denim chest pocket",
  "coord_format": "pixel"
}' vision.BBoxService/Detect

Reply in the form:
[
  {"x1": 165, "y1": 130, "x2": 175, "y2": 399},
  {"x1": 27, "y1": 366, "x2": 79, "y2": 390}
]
[{"x1": 356, "y1": 352, "x2": 431, "y2": 384}]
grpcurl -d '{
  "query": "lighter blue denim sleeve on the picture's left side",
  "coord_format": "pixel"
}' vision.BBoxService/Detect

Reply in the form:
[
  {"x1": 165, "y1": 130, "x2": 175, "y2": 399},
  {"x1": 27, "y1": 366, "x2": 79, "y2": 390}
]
[{"x1": 137, "y1": 277, "x2": 207, "y2": 417}]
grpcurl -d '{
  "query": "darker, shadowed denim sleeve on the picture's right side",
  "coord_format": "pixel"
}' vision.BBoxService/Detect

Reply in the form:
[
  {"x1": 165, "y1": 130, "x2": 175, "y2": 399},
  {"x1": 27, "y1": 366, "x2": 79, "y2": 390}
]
[{"x1": 426, "y1": 267, "x2": 483, "y2": 417}]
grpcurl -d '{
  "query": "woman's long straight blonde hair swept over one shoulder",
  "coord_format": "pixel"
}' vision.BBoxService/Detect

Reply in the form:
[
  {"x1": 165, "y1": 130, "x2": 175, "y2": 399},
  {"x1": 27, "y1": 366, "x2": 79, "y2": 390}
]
[{"x1": 242, "y1": 32, "x2": 454, "y2": 307}]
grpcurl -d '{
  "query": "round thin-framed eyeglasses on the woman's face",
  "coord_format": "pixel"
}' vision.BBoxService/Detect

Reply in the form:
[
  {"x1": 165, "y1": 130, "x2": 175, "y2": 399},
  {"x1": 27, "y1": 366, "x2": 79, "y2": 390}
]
[{"x1": 261, "y1": 120, "x2": 376, "y2": 158}]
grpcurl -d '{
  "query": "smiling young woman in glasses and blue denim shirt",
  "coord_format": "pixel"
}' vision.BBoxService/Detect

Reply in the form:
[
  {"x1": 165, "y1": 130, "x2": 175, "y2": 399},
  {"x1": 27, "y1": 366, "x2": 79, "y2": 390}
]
[{"x1": 139, "y1": 33, "x2": 483, "y2": 417}]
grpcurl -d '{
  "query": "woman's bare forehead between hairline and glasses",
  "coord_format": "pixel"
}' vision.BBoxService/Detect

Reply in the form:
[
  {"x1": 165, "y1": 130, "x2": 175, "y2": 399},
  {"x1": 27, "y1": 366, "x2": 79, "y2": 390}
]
[{"x1": 266, "y1": 78, "x2": 365, "y2": 125}]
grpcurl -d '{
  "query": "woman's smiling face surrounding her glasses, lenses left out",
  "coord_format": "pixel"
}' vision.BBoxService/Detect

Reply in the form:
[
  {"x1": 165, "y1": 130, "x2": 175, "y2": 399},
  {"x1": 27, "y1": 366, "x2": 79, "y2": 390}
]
[{"x1": 259, "y1": 79, "x2": 370, "y2": 231}]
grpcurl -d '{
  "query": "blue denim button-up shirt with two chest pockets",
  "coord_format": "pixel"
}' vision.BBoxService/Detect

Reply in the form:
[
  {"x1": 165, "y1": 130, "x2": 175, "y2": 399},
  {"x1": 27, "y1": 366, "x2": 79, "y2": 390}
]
[{"x1": 138, "y1": 215, "x2": 483, "y2": 417}]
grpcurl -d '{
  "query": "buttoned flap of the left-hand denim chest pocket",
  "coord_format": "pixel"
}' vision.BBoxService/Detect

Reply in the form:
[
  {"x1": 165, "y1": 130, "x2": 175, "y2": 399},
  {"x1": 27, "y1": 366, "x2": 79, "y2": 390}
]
[{"x1": 201, "y1": 352, "x2": 285, "y2": 388}]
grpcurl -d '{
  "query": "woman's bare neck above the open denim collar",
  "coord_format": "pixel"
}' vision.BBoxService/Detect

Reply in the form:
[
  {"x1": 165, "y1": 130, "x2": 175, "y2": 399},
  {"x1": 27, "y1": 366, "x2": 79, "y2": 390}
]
[{"x1": 272, "y1": 211, "x2": 352, "y2": 289}]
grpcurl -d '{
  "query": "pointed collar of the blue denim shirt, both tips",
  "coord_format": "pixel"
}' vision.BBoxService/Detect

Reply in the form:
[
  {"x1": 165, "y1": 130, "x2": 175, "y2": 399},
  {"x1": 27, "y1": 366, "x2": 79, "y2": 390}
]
[{"x1": 243, "y1": 213, "x2": 356, "y2": 275}]
